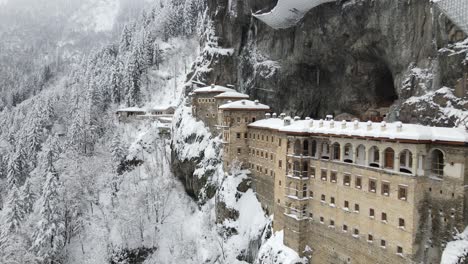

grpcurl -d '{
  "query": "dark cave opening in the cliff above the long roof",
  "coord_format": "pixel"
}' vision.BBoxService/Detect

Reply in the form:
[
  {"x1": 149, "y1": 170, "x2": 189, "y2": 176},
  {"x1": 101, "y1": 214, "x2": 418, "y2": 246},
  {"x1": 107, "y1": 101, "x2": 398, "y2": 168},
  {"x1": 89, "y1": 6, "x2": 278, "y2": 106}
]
[{"x1": 374, "y1": 65, "x2": 398, "y2": 108}]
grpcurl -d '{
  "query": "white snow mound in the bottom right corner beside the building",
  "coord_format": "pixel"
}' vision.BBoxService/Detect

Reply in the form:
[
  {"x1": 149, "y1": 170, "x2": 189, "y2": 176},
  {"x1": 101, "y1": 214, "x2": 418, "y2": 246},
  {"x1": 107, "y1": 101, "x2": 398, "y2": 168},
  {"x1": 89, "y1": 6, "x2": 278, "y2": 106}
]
[{"x1": 440, "y1": 228, "x2": 468, "y2": 264}]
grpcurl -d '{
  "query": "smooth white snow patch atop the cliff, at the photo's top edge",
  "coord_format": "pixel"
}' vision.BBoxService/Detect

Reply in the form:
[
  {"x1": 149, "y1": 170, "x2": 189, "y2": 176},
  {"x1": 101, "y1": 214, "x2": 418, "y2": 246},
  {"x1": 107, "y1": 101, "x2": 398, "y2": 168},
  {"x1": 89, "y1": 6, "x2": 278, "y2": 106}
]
[{"x1": 253, "y1": 0, "x2": 336, "y2": 29}]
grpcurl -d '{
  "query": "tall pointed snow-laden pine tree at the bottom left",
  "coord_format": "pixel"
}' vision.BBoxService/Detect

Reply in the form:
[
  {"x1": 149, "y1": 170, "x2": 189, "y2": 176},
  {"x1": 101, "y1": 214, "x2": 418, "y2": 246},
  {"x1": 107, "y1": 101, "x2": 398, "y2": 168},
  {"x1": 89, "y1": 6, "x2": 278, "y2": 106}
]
[{"x1": 32, "y1": 161, "x2": 65, "y2": 263}]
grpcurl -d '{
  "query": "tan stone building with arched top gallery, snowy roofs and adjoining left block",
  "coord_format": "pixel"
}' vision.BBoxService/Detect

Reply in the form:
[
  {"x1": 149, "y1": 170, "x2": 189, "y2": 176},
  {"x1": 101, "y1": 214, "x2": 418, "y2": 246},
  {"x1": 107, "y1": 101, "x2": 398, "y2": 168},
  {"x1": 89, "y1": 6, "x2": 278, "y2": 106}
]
[{"x1": 190, "y1": 87, "x2": 468, "y2": 263}]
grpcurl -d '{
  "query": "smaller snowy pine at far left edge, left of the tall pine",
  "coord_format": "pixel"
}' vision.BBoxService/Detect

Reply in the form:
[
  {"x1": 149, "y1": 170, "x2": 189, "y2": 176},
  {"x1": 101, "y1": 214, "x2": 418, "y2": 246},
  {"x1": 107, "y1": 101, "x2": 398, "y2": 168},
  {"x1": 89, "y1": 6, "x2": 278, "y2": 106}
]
[{"x1": 5, "y1": 184, "x2": 25, "y2": 233}]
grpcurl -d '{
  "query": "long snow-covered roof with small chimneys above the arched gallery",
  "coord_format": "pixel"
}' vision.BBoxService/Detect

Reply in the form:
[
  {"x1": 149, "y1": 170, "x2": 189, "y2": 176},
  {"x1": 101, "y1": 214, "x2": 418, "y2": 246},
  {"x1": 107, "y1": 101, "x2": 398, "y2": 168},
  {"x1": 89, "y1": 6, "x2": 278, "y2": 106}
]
[{"x1": 249, "y1": 118, "x2": 468, "y2": 143}]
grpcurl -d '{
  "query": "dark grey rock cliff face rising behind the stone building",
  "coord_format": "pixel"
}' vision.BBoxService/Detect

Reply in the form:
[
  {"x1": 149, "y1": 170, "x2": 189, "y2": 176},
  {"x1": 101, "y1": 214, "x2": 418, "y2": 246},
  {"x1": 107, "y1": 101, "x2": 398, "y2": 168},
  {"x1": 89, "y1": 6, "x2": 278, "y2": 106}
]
[{"x1": 209, "y1": 0, "x2": 466, "y2": 125}]
